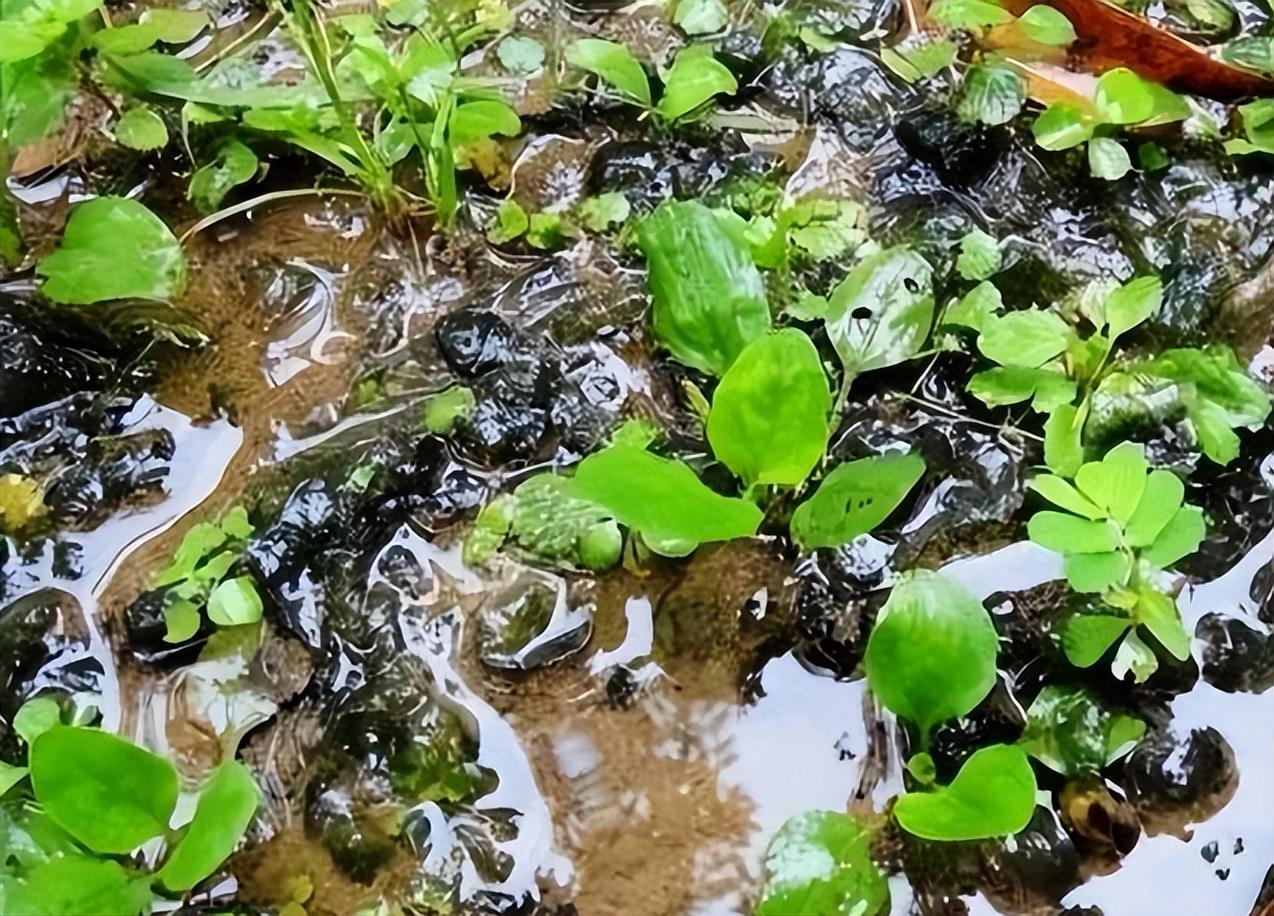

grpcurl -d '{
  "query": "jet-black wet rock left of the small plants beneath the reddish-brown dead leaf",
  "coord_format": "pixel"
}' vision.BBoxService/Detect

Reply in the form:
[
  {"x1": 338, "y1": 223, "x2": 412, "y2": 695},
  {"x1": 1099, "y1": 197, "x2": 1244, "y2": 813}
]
[{"x1": 893, "y1": 104, "x2": 1009, "y2": 187}]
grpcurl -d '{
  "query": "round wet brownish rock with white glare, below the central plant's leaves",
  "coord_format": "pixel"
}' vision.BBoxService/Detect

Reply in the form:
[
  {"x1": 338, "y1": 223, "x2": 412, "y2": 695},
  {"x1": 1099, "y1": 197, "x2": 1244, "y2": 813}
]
[{"x1": 478, "y1": 569, "x2": 592, "y2": 671}]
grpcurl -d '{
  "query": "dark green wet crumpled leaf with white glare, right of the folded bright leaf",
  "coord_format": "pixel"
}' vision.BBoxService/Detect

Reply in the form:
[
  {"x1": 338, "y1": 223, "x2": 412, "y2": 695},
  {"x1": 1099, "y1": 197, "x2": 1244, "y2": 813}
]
[{"x1": 1018, "y1": 684, "x2": 1145, "y2": 777}]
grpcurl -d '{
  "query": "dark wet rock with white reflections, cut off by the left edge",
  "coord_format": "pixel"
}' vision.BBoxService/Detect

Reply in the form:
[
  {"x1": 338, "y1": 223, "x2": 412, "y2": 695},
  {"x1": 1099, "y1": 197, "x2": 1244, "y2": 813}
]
[{"x1": 0, "y1": 589, "x2": 106, "y2": 721}]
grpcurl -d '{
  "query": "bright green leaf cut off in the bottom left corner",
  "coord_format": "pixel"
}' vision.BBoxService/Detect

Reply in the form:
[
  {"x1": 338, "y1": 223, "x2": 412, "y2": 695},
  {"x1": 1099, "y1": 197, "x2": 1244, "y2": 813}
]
[{"x1": 0, "y1": 855, "x2": 152, "y2": 916}]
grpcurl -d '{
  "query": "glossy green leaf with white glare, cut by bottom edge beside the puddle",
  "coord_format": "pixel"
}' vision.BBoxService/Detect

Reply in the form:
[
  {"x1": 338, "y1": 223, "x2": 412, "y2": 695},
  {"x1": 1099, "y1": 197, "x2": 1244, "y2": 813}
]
[{"x1": 753, "y1": 812, "x2": 889, "y2": 916}]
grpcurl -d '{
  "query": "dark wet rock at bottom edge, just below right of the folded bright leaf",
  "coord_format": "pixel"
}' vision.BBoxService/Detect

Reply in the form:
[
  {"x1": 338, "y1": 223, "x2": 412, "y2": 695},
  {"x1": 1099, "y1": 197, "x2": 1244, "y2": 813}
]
[{"x1": 982, "y1": 806, "x2": 1083, "y2": 912}]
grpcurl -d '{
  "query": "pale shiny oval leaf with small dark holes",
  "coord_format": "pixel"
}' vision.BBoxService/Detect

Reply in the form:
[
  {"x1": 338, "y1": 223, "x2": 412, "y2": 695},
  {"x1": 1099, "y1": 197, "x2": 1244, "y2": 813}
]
[{"x1": 827, "y1": 247, "x2": 934, "y2": 376}]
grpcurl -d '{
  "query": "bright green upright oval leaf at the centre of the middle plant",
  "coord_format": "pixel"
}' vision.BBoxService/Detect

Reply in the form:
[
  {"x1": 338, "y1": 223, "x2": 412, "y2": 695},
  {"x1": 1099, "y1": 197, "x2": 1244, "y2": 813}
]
[{"x1": 707, "y1": 327, "x2": 832, "y2": 487}]
